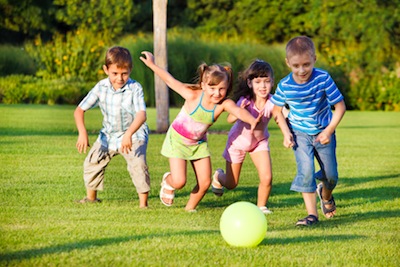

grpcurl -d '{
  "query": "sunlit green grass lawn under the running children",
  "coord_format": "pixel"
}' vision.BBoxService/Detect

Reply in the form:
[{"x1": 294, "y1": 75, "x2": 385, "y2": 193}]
[{"x1": 0, "y1": 105, "x2": 400, "y2": 266}]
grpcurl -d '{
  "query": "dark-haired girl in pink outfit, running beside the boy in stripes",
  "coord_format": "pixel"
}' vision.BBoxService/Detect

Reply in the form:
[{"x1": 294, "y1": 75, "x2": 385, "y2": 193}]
[{"x1": 211, "y1": 60, "x2": 284, "y2": 214}]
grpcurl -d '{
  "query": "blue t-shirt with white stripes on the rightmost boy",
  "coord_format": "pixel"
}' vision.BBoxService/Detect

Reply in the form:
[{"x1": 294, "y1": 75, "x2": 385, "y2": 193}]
[{"x1": 271, "y1": 68, "x2": 343, "y2": 135}]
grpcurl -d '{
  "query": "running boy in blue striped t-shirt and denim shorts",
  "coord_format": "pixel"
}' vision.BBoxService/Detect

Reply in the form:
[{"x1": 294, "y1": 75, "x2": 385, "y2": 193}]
[{"x1": 271, "y1": 36, "x2": 346, "y2": 226}]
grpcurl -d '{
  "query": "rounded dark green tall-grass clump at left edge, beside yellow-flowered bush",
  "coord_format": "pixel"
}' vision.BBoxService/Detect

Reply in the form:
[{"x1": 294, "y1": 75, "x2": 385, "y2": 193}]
[{"x1": 0, "y1": 45, "x2": 36, "y2": 77}]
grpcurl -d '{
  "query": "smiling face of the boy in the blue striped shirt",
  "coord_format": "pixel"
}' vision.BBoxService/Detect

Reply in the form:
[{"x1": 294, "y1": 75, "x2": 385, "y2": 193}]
[{"x1": 286, "y1": 53, "x2": 317, "y2": 84}]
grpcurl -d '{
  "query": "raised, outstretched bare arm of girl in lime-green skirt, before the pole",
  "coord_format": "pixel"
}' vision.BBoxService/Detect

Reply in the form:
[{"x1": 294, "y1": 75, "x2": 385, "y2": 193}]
[{"x1": 140, "y1": 51, "x2": 193, "y2": 99}]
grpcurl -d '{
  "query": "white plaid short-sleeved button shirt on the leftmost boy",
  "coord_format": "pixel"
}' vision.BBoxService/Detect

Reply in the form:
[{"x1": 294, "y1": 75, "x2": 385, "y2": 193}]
[{"x1": 79, "y1": 78, "x2": 149, "y2": 150}]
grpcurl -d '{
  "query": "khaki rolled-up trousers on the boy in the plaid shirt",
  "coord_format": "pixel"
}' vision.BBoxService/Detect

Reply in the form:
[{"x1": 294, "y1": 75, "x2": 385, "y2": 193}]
[{"x1": 83, "y1": 140, "x2": 150, "y2": 193}]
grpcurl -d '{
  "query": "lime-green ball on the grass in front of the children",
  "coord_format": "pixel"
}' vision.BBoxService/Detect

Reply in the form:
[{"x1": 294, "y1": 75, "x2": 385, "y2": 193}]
[{"x1": 219, "y1": 201, "x2": 267, "y2": 247}]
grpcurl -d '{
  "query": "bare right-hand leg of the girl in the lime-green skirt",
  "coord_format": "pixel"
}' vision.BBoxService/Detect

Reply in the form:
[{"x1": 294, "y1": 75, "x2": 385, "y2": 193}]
[{"x1": 185, "y1": 157, "x2": 211, "y2": 211}]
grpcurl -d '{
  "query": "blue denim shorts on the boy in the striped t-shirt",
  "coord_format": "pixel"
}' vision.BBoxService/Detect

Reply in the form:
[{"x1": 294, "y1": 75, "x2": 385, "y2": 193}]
[{"x1": 290, "y1": 131, "x2": 338, "y2": 193}]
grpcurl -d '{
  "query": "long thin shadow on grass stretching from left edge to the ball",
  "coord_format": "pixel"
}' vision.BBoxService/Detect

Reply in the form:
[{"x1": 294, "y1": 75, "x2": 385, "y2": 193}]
[{"x1": 0, "y1": 230, "x2": 219, "y2": 265}]
